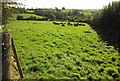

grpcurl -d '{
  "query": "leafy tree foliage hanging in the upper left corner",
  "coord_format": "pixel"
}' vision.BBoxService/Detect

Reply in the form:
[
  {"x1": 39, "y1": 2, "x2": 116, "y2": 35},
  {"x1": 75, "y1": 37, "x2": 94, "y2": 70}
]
[{"x1": 2, "y1": 2, "x2": 25, "y2": 25}]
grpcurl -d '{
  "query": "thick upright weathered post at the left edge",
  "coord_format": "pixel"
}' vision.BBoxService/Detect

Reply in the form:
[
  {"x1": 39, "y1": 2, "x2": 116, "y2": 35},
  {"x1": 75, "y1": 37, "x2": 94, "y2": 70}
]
[{"x1": 2, "y1": 32, "x2": 11, "y2": 79}]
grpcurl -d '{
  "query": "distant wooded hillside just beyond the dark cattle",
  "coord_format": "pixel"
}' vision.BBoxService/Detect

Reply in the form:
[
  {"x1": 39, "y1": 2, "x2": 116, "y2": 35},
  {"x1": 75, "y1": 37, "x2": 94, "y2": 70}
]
[{"x1": 34, "y1": 9, "x2": 89, "y2": 22}]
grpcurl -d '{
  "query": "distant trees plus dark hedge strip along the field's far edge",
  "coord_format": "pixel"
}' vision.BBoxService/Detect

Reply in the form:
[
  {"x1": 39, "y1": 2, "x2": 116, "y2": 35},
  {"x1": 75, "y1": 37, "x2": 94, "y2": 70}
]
[{"x1": 17, "y1": 8, "x2": 90, "y2": 23}]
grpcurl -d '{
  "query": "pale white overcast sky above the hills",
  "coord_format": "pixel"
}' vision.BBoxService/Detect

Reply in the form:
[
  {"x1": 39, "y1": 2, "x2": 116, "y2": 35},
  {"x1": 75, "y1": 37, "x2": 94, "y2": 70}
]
[{"x1": 16, "y1": 0, "x2": 119, "y2": 9}]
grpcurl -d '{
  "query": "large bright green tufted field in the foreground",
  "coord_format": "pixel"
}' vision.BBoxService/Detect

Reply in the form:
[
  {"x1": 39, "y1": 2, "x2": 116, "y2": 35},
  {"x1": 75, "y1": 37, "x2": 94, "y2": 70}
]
[{"x1": 8, "y1": 20, "x2": 120, "y2": 79}]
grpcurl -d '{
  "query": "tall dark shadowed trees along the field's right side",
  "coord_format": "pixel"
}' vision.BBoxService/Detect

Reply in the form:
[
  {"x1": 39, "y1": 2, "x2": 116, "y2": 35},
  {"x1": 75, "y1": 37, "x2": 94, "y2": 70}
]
[{"x1": 91, "y1": 1, "x2": 120, "y2": 47}]
